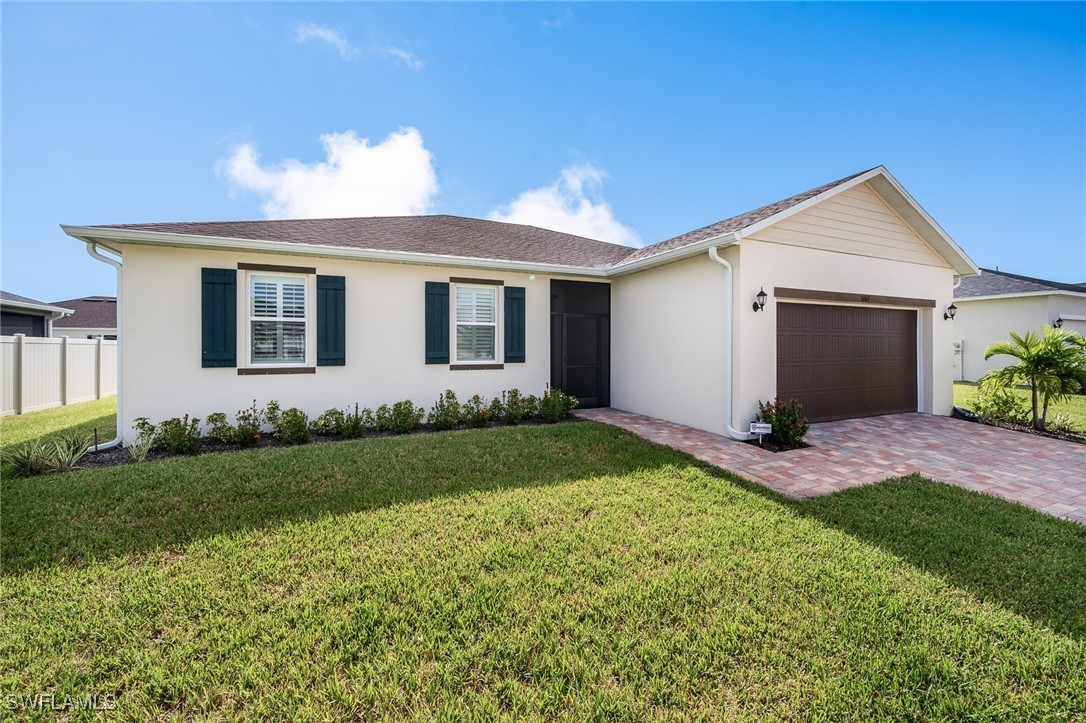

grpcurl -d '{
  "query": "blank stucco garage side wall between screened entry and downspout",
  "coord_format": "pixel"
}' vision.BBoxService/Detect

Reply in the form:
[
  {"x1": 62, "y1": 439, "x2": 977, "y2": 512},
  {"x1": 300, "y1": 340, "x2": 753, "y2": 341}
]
[{"x1": 611, "y1": 250, "x2": 737, "y2": 432}]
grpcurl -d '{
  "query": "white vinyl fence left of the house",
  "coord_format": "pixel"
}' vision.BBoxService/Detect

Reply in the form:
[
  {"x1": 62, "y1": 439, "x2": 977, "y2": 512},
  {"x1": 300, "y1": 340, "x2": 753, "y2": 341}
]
[{"x1": 0, "y1": 334, "x2": 117, "y2": 416}]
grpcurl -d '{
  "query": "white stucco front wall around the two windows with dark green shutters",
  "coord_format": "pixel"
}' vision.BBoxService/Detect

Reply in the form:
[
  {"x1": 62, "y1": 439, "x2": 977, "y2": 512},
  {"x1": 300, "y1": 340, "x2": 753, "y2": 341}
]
[{"x1": 121, "y1": 245, "x2": 599, "y2": 433}]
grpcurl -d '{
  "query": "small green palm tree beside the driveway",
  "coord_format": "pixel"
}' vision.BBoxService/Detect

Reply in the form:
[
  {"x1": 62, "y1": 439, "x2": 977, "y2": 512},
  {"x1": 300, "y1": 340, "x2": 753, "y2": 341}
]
[{"x1": 981, "y1": 327, "x2": 1086, "y2": 430}]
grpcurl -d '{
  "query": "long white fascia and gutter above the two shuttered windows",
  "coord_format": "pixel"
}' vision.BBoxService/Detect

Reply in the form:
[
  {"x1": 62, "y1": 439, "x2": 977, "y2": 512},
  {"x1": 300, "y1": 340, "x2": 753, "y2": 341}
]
[{"x1": 61, "y1": 225, "x2": 607, "y2": 278}]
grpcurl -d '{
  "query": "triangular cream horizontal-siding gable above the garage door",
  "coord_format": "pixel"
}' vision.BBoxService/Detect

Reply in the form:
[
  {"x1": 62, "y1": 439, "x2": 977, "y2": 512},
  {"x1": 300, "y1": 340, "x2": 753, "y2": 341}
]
[{"x1": 750, "y1": 183, "x2": 949, "y2": 268}]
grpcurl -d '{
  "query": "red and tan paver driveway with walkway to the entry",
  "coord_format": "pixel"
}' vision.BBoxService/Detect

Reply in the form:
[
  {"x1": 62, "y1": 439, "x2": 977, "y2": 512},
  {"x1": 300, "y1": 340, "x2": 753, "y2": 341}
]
[{"x1": 576, "y1": 409, "x2": 1086, "y2": 523}]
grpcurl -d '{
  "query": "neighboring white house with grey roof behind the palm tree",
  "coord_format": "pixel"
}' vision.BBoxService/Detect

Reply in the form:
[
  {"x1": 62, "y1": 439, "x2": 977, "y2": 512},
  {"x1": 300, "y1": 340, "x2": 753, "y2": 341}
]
[{"x1": 954, "y1": 268, "x2": 1086, "y2": 381}]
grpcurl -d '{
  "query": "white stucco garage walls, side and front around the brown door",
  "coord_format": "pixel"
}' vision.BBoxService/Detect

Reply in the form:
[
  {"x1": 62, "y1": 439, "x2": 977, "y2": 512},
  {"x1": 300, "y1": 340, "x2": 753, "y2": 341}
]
[{"x1": 611, "y1": 233, "x2": 954, "y2": 433}]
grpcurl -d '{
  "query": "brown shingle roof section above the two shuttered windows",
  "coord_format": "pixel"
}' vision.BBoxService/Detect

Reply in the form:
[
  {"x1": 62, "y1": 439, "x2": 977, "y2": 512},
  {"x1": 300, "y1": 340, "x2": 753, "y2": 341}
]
[{"x1": 98, "y1": 216, "x2": 630, "y2": 268}]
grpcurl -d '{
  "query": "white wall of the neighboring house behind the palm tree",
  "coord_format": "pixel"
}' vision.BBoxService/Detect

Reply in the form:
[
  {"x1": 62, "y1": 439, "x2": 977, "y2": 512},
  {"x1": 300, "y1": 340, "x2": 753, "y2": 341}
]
[{"x1": 951, "y1": 294, "x2": 1086, "y2": 381}]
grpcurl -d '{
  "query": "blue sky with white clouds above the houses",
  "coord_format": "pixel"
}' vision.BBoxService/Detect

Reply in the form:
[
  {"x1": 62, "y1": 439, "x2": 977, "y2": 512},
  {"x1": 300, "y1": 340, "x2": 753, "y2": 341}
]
[{"x1": 2, "y1": 2, "x2": 1086, "y2": 301}]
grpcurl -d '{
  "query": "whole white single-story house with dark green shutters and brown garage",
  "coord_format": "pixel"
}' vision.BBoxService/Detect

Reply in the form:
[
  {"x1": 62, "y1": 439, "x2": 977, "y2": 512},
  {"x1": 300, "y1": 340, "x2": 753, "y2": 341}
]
[{"x1": 63, "y1": 166, "x2": 977, "y2": 437}]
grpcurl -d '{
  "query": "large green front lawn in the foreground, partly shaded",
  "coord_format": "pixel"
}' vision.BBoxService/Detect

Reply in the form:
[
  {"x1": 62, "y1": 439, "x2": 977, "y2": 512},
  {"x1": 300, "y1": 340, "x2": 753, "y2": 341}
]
[{"x1": 0, "y1": 422, "x2": 1086, "y2": 721}]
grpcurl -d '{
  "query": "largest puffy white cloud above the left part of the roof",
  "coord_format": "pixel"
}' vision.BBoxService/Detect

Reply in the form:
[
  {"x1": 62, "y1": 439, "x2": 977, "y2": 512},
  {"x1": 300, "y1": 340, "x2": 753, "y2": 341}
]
[{"x1": 218, "y1": 128, "x2": 438, "y2": 218}]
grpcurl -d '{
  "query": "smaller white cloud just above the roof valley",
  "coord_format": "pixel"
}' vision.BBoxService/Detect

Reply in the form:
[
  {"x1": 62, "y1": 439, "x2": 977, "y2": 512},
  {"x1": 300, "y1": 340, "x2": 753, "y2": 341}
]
[{"x1": 489, "y1": 164, "x2": 642, "y2": 246}]
